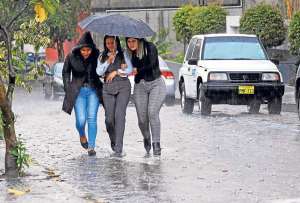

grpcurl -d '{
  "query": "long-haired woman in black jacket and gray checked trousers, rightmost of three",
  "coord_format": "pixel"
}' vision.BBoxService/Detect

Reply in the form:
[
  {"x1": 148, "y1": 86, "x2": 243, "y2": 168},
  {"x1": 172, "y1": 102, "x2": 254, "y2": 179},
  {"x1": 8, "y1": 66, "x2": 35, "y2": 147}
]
[{"x1": 126, "y1": 38, "x2": 166, "y2": 155}]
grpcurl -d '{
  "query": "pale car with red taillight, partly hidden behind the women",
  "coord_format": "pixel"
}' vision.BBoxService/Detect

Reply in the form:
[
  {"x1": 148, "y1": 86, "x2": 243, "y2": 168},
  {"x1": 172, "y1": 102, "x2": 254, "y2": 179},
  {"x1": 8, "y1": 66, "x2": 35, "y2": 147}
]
[{"x1": 128, "y1": 56, "x2": 176, "y2": 106}]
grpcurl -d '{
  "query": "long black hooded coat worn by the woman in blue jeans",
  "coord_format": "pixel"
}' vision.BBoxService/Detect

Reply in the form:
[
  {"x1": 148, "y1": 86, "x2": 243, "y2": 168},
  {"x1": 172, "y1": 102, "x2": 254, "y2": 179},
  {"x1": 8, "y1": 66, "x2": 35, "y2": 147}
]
[{"x1": 62, "y1": 32, "x2": 102, "y2": 114}]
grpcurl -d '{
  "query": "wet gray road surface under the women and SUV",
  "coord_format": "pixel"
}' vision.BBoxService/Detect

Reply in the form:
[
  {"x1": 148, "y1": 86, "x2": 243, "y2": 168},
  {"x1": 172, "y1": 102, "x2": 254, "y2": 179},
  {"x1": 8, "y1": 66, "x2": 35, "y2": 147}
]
[{"x1": 0, "y1": 83, "x2": 300, "y2": 203}]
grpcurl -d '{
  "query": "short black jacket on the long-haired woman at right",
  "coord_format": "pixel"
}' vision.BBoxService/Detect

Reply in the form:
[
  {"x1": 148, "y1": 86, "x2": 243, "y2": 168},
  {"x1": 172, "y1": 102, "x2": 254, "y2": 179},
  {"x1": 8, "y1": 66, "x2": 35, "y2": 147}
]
[{"x1": 132, "y1": 40, "x2": 161, "y2": 83}]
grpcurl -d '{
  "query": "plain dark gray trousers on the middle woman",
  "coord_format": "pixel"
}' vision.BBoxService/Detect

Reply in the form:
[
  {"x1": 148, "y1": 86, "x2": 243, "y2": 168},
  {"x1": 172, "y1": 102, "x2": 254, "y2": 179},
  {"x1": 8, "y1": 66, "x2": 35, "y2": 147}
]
[{"x1": 103, "y1": 79, "x2": 130, "y2": 153}]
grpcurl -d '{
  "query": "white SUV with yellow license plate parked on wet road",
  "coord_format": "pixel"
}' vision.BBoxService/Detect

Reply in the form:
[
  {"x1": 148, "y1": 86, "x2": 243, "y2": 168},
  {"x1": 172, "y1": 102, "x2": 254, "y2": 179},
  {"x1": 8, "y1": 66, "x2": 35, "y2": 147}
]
[{"x1": 179, "y1": 34, "x2": 284, "y2": 115}]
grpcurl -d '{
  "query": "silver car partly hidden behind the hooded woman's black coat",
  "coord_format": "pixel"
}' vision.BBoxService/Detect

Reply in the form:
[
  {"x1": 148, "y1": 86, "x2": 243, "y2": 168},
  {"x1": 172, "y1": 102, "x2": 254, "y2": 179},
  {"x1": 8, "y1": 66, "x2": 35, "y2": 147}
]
[{"x1": 43, "y1": 62, "x2": 65, "y2": 99}]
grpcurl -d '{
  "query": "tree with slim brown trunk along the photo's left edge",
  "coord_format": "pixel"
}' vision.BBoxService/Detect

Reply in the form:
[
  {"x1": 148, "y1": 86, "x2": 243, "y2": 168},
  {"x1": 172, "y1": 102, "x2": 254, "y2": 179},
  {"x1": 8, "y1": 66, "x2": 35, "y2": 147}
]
[{"x1": 0, "y1": 0, "x2": 59, "y2": 176}]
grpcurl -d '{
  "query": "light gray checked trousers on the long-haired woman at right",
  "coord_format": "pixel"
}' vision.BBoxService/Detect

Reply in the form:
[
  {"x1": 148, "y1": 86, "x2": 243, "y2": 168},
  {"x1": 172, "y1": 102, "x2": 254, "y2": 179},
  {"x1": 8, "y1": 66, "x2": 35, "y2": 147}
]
[{"x1": 133, "y1": 78, "x2": 166, "y2": 142}]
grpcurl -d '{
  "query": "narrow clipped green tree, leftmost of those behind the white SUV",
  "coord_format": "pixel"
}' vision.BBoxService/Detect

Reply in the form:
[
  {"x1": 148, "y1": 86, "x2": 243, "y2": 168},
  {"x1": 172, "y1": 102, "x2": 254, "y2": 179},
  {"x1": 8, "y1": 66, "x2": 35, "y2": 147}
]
[{"x1": 173, "y1": 5, "x2": 193, "y2": 51}]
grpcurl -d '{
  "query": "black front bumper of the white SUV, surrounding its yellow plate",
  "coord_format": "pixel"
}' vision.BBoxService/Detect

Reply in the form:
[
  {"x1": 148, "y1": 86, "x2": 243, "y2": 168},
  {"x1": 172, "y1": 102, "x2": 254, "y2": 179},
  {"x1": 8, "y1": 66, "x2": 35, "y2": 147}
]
[{"x1": 201, "y1": 83, "x2": 284, "y2": 105}]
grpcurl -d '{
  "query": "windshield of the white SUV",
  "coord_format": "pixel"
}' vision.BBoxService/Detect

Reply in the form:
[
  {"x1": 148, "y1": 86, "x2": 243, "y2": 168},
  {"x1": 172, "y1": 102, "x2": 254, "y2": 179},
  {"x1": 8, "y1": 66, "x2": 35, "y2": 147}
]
[{"x1": 202, "y1": 36, "x2": 267, "y2": 60}]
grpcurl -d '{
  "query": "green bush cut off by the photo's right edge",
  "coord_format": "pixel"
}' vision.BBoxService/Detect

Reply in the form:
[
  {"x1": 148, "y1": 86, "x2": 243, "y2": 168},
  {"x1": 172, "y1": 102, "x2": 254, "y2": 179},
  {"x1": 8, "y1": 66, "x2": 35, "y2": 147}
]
[{"x1": 289, "y1": 11, "x2": 300, "y2": 55}]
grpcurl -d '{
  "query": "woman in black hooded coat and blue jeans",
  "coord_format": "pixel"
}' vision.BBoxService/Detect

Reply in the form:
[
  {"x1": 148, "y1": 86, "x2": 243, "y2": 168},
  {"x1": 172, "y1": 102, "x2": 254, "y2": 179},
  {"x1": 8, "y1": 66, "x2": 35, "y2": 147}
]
[{"x1": 62, "y1": 32, "x2": 102, "y2": 156}]
